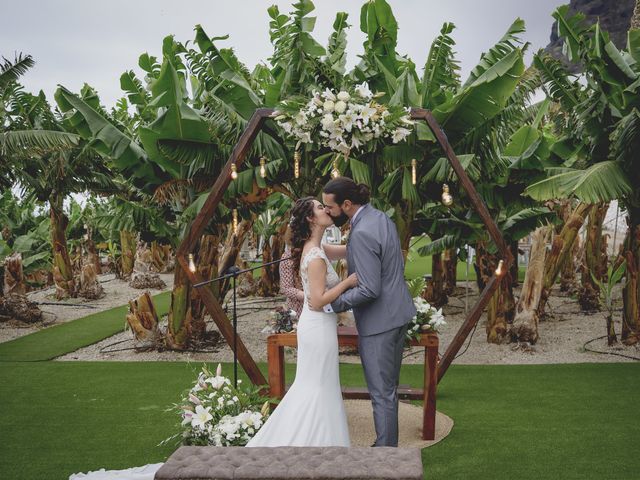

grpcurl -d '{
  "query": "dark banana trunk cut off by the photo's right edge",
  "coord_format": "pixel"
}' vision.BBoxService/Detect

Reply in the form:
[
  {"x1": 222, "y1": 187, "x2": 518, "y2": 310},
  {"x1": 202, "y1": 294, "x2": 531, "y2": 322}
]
[{"x1": 620, "y1": 209, "x2": 640, "y2": 345}]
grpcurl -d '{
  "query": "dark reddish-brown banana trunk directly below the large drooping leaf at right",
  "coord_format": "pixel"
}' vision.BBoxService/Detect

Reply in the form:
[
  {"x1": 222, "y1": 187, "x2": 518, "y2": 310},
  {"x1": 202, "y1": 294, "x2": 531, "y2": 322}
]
[{"x1": 578, "y1": 203, "x2": 609, "y2": 312}]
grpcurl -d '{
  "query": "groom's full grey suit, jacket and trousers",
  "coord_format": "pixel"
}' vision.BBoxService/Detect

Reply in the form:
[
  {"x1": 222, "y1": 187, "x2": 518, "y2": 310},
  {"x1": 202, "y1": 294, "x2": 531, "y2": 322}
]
[{"x1": 331, "y1": 204, "x2": 416, "y2": 447}]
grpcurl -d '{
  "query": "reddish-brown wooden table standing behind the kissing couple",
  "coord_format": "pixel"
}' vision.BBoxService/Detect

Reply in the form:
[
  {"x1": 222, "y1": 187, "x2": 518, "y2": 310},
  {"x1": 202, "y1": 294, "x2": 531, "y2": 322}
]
[{"x1": 267, "y1": 327, "x2": 439, "y2": 440}]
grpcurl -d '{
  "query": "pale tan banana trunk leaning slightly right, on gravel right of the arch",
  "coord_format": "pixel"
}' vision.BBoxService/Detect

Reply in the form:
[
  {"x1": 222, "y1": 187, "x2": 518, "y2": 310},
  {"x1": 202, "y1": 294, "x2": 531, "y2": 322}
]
[{"x1": 511, "y1": 227, "x2": 551, "y2": 344}]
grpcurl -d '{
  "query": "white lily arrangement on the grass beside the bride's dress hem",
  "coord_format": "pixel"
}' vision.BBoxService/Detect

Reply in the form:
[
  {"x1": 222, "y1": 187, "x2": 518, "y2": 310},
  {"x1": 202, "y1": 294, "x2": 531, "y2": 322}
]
[{"x1": 162, "y1": 365, "x2": 270, "y2": 447}]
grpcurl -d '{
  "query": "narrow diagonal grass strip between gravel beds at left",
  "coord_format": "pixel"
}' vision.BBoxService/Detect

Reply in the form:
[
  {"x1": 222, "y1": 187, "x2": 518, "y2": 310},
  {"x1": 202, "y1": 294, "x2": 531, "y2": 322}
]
[{"x1": 0, "y1": 292, "x2": 171, "y2": 362}]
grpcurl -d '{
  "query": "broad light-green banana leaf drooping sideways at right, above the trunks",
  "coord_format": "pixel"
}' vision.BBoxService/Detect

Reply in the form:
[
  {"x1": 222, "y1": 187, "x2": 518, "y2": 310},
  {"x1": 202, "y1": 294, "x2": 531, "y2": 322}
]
[{"x1": 524, "y1": 161, "x2": 633, "y2": 203}]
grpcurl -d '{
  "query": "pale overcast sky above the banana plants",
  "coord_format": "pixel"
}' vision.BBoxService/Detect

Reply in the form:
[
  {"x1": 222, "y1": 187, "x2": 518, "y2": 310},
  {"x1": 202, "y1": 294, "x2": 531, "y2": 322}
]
[{"x1": 0, "y1": 0, "x2": 568, "y2": 106}]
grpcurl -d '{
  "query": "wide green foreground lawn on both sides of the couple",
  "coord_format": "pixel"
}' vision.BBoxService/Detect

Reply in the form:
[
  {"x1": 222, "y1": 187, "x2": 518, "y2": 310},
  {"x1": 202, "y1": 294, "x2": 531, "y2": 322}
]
[{"x1": 0, "y1": 362, "x2": 640, "y2": 480}]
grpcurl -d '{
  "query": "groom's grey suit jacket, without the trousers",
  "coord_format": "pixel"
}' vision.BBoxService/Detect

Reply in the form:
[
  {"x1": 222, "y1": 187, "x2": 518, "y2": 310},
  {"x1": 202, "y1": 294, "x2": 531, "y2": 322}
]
[{"x1": 331, "y1": 204, "x2": 416, "y2": 336}]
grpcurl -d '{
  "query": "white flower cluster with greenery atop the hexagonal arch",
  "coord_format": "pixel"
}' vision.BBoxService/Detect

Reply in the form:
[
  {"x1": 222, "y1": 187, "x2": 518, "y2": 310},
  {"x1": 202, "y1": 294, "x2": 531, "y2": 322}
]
[{"x1": 274, "y1": 83, "x2": 414, "y2": 157}]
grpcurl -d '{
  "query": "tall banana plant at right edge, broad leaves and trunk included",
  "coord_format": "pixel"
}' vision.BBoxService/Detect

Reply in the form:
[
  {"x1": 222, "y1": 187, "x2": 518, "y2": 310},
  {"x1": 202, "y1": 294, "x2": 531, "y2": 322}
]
[{"x1": 525, "y1": 7, "x2": 640, "y2": 344}]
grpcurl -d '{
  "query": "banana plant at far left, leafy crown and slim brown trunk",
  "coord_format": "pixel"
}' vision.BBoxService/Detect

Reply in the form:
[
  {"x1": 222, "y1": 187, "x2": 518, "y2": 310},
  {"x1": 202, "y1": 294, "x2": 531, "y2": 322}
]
[{"x1": 0, "y1": 84, "x2": 118, "y2": 298}]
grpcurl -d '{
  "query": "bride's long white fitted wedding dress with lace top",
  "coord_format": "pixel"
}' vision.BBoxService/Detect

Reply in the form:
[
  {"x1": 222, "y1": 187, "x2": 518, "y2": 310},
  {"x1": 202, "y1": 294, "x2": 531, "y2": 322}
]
[{"x1": 247, "y1": 247, "x2": 350, "y2": 447}]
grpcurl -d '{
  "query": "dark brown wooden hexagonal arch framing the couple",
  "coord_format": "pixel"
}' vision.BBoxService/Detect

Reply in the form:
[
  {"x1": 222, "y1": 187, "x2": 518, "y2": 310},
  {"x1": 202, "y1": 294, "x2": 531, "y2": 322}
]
[{"x1": 176, "y1": 108, "x2": 513, "y2": 385}]
